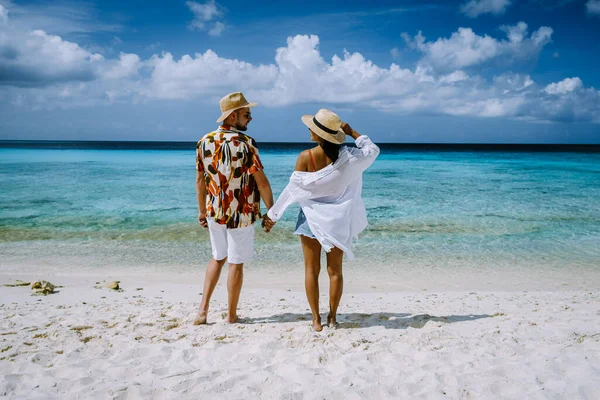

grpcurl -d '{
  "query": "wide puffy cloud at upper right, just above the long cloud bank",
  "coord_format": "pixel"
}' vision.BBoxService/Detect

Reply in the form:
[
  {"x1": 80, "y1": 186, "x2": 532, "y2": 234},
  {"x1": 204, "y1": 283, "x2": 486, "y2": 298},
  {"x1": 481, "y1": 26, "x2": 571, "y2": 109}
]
[{"x1": 402, "y1": 22, "x2": 553, "y2": 70}]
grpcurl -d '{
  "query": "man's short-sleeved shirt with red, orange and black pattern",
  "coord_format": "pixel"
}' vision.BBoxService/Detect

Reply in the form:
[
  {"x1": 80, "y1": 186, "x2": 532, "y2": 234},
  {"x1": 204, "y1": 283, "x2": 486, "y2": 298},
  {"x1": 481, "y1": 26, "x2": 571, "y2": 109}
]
[{"x1": 196, "y1": 126, "x2": 263, "y2": 229}]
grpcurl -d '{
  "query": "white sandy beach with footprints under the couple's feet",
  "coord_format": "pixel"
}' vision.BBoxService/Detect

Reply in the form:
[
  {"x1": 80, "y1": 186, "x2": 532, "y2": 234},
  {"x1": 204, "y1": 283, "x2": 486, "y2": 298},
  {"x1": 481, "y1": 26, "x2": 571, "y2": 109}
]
[{"x1": 0, "y1": 272, "x2": 600, "y2": 399}]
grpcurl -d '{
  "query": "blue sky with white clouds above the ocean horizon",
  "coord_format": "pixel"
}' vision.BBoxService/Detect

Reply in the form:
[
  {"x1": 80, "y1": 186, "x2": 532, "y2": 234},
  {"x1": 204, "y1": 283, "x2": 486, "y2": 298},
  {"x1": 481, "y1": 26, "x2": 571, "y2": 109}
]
[{"x1": 0, "y1": 0, "x2": 600, "y2": 143}]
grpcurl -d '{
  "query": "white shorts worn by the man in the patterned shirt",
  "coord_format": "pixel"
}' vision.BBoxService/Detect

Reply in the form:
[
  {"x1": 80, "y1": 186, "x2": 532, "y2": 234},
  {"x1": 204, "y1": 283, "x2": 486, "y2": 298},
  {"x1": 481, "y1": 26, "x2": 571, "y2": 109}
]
[{"x1": 207, "y1": 218, "x2": 254, "y2": 264}]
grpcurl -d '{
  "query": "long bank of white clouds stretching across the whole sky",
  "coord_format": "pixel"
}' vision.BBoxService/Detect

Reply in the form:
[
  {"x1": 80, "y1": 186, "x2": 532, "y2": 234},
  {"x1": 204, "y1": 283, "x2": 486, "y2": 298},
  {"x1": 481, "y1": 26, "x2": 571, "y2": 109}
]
[{"x1": 0, "y1": 14, "x2": 600, "y2": 123}]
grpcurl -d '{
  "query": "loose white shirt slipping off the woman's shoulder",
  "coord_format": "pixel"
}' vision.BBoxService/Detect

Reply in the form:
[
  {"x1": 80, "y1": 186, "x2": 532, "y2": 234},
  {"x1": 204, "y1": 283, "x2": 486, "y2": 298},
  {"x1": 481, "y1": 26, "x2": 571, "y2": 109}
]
[{"x1": 267, "y1": 135, "x2": 379, "y2": 260}]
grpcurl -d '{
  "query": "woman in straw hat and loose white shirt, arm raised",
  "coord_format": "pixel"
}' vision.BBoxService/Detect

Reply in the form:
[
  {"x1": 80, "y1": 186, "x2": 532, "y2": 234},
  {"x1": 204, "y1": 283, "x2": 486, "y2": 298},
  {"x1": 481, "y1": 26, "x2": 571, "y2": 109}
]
[{"x1": 264, "y1": 109, "x2": 379, "y2": 332}]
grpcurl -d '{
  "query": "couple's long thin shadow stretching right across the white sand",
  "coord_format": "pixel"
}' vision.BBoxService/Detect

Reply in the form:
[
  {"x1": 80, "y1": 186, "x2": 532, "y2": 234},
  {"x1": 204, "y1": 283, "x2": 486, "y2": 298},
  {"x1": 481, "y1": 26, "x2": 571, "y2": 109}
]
[{"x1": 245, "y1": 312, "x2": 491, "y2": 329}]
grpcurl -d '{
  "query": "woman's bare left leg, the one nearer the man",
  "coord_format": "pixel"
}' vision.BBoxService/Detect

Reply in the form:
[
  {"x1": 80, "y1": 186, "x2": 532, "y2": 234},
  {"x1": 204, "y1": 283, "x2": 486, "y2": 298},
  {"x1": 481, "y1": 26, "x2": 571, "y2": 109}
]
[{"x1": 300, "y1": 236, "x2": 323, "y2": 332}]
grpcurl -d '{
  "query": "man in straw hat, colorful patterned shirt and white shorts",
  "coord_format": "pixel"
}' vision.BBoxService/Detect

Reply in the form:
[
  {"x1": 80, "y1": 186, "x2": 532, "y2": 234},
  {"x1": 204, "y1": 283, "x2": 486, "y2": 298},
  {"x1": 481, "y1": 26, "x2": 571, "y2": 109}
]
[{"x1": 194, "y1": 92, "x2": 273, "y2": 325}]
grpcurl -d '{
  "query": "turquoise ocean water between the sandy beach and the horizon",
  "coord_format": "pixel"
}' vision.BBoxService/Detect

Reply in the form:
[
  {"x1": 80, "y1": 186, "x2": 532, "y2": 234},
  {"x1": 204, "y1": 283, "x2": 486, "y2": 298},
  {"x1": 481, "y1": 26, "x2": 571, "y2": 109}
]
[{"x1": 0, "y1": 143, "x2": 600, "y2": 273}]
